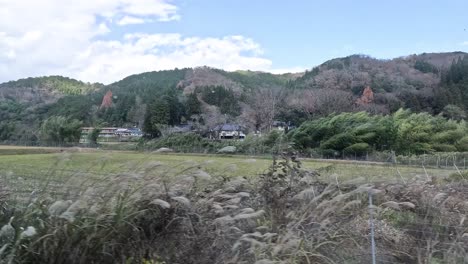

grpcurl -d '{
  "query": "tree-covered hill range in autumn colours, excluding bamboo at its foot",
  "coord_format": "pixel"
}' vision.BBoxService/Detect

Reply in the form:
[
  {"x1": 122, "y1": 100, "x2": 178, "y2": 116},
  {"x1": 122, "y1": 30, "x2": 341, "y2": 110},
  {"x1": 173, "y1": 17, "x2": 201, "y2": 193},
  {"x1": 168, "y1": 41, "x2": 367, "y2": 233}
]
[{"x1": 0, "y1": 52, "x2": 468, "y2": 141}]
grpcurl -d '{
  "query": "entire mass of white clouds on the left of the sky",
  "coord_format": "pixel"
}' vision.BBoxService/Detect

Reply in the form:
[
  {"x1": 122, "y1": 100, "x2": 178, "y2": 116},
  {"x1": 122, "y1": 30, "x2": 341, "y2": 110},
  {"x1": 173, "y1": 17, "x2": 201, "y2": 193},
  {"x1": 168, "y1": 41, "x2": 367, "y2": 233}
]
[{"x1": 0, "y1": 0, "x2": 294, "y2": 83}]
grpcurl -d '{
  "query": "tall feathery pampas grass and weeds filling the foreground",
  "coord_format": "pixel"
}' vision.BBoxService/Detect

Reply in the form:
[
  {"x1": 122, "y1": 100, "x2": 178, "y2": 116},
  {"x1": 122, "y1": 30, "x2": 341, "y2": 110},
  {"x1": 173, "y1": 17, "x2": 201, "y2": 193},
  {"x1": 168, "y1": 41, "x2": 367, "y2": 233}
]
[{"x1": 0, "y1": 153, "x2": 468, "y2": 263}]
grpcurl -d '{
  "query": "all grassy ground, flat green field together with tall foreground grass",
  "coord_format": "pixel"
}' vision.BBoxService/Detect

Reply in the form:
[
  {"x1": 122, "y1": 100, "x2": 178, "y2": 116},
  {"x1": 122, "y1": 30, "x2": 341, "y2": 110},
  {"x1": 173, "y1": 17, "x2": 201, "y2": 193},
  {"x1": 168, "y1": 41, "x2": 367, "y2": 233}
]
[{"x1": 0, "y1": 147, "x2": 468, "y2": 263}]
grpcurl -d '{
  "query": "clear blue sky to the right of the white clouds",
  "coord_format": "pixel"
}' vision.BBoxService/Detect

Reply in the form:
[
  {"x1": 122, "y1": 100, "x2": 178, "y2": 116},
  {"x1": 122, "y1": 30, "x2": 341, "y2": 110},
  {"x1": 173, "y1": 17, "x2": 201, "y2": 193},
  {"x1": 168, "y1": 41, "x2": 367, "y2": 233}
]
[{"x1": 173, "y1": 0, "x2": 468, "y2": 68}]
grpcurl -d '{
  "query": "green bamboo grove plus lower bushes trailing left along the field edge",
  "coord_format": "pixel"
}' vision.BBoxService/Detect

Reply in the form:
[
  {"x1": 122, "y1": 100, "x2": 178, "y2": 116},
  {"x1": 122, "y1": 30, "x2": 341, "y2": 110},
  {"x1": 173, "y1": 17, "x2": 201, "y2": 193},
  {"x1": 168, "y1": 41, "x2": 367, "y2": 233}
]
[{"x1": 140, "y1": 109, "x2": 468, "y2": 157}]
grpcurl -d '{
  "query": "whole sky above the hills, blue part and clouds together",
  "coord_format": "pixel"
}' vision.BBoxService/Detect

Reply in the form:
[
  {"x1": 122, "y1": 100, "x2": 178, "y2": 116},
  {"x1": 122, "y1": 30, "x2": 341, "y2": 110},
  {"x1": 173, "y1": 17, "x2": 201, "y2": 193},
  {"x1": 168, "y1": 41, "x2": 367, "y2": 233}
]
[{"x1": 0, "y1": 0, "x2": 468, "y2": 84}]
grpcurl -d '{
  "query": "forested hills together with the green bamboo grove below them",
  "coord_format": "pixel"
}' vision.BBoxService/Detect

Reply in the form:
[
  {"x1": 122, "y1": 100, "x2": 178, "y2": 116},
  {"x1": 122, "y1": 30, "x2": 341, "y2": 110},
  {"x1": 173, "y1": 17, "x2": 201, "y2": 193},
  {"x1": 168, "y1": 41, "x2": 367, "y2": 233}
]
[{"x1": 0, "y1": 52, "x2": 468, "y2": 152}]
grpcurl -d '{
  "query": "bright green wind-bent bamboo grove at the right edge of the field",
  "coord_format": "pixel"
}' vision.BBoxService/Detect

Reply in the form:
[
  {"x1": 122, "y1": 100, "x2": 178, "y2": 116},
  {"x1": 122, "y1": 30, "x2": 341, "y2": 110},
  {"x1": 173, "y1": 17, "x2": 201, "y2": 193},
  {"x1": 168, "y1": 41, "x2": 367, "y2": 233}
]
[{"x1": 290, "y1": 109, "x2": 468, "y2": 156}]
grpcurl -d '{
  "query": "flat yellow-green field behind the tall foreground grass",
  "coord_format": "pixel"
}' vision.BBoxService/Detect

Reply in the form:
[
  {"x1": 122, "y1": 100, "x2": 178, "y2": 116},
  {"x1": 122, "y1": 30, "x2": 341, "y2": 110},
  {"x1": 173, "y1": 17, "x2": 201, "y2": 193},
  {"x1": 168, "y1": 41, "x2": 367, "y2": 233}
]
[{"x1": 0, "y1": 146, "x2": 453, "y2": 201}]
